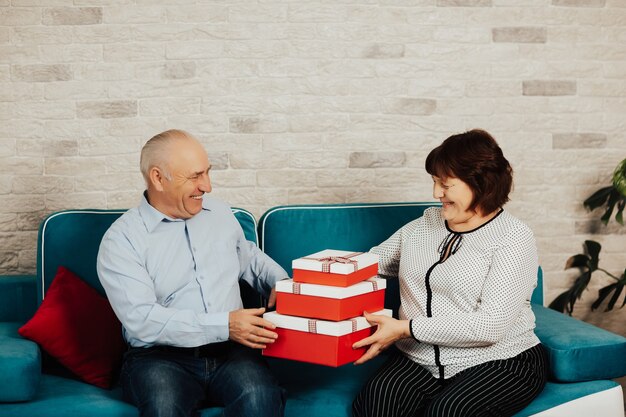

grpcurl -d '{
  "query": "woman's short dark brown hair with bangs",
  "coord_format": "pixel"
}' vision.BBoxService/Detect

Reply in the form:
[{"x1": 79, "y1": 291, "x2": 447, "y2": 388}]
[{"x1": 426, "y1": 129, "x2": 513, "y2": 214}]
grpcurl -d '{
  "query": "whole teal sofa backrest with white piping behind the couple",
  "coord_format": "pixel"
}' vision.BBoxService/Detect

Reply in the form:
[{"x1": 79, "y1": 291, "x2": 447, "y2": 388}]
[{"x1": 37, "y1": 202, "x2": 543, "y2": 307}]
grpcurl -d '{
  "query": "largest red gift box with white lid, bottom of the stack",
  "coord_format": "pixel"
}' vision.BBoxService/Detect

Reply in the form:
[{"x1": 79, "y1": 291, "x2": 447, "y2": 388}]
[{"x1": 263, "y1": 310, "x2": 391, "y2": 367}]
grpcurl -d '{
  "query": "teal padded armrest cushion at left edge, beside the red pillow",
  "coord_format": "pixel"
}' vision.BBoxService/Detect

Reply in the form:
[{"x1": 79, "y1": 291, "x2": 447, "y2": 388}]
[{"x1": 0, "y1": 322, "x2": 41, "y2": 402}]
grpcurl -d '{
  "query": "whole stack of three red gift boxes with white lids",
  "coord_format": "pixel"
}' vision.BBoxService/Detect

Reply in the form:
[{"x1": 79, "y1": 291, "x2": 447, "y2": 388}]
[{"x1": 263, "y1": 249, "x2": 391, "y2": 367}]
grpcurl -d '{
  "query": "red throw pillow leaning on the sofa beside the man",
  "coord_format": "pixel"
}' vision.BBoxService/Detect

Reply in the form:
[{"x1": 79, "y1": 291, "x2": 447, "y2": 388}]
[{"x1": 19, "y1": 266, "x2": 126, "y2": 388}]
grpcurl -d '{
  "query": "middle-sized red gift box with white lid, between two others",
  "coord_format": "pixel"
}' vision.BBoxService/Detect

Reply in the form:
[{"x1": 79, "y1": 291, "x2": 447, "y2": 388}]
[{"x1": 276, "y1": 277, "x2": 387, "y2": 321}]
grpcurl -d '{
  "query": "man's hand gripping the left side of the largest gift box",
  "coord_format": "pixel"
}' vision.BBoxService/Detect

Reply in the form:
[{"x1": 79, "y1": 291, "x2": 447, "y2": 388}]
[{"x1": 228, "y1": 308, "x2": 278, "y2": 349}]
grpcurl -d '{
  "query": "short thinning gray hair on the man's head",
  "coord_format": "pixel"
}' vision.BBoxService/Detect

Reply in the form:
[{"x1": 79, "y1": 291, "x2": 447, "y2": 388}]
[{"x1": 139, "y1": 129, "x2": 193, "y2": 186}]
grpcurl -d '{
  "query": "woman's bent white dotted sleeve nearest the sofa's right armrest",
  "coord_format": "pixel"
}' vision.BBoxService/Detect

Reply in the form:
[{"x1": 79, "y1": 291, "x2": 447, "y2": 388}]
[{"x1": 411, "y1": 223, "x2": 538, "y2": 347}]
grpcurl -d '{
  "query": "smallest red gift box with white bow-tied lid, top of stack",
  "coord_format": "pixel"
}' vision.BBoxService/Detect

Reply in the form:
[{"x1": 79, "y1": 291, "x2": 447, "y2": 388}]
[{"x1": 291, "y1": 249, "x2": 378, "y2": 287}]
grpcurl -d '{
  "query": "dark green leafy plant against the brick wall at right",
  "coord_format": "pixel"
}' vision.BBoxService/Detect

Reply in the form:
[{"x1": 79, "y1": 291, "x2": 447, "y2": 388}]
[{"x1": 549, "y1": 159, "x2": 626, "y2": 315}]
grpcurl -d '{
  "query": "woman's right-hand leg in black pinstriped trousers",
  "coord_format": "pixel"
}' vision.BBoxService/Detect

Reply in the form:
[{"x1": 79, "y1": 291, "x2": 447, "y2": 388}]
[{"x1": 425, "y1": 345, "x2": 548, "y2": 417}]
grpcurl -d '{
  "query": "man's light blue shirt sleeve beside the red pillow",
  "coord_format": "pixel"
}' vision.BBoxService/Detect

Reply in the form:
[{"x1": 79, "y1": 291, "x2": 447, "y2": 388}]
[{"x1": 97, "y1": 226, "x2": 228, "y2": 347}]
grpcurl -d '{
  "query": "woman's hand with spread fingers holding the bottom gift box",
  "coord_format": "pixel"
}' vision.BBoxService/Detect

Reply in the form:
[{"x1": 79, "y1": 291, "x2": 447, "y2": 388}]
[{"x1": 352, "y1": 312, "x2": 411, "y2": 365}]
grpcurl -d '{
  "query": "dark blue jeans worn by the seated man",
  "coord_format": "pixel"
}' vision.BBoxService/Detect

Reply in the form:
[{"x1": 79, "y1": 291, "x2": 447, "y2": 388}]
[{"x1": 120, "y1": 343, "x2": 285, "y2": 417}]
